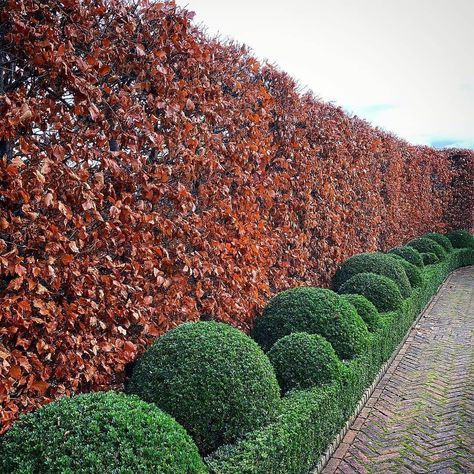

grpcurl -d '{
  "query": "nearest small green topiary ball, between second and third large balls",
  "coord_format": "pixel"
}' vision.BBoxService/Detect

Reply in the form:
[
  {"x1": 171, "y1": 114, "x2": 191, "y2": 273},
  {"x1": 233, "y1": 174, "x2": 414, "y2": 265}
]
[{"x1": 268, "y1": 332, "x2": 343, "y2": 393}]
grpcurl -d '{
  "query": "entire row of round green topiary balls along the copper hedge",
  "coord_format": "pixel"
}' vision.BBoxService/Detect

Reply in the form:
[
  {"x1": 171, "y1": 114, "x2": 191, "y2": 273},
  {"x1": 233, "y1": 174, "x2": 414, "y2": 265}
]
[{"x1": 0, "y1": 231, "x2": 474, "y2": 474}]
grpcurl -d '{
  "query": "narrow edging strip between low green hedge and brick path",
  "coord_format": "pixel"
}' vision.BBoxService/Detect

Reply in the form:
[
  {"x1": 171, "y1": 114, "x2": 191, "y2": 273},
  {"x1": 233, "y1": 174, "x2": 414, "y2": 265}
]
[{"x1": 309, "y1": 269, "x2": 458, "y2": 474}]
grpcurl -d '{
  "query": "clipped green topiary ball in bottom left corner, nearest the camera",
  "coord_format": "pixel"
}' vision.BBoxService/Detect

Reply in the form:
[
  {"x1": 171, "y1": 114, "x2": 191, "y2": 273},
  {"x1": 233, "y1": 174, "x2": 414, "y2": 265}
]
[{"x1": 0, "y1": 392, "x2": 207, "y2": 474}]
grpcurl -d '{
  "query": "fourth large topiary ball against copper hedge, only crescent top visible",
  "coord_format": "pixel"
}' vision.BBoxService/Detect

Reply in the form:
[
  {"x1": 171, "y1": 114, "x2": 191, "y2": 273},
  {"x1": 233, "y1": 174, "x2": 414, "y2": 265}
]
[{"x1": 332, "y1": 252, "x2": 412, "y2": 298}]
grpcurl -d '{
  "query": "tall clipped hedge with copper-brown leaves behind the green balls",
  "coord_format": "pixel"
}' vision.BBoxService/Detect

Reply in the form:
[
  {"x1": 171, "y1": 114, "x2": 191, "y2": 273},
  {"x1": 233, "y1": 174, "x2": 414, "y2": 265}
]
[{"x1": 0, "y1": 0, "x2": 474, "y2": 430}]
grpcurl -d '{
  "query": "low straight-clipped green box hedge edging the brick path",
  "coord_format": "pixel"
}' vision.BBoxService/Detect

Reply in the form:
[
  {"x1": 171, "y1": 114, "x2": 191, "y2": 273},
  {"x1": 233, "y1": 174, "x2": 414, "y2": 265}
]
[{"x1": 206, "y1": 249, "x2": 474, "y2": 474}]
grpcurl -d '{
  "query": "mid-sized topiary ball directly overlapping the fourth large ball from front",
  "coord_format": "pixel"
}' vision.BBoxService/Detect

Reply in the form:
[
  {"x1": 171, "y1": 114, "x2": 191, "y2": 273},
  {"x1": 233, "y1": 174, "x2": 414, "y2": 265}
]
[{"x1": 339, "y1": 273, "x2": 403, "y2": 312}]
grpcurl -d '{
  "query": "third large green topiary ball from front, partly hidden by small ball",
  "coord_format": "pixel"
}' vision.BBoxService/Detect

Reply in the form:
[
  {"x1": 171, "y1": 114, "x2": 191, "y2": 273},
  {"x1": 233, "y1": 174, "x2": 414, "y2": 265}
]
[{"x1": 252, "y1": 287, "x2": 368, "y2": 359}]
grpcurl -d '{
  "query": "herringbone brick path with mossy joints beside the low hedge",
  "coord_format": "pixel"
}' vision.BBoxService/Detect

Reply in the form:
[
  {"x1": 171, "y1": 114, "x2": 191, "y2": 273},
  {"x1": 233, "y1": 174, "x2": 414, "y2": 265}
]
[{"x1": 323, "y1": 266, "x2": 474, "y2": 474}]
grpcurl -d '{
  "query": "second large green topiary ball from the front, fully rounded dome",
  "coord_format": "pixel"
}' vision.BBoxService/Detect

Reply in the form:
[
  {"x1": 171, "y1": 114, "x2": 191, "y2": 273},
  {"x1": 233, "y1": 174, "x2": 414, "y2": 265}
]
[{"x1": 128, "y1": 321, "x2": 280, "y2": 454}]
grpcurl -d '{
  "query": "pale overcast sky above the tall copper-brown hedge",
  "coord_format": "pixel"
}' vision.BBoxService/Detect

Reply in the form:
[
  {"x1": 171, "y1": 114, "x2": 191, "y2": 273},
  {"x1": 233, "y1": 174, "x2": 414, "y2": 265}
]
[{"x1": 177, "y1": 0, "x2": 474, "y2": 149}]
